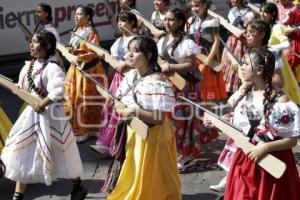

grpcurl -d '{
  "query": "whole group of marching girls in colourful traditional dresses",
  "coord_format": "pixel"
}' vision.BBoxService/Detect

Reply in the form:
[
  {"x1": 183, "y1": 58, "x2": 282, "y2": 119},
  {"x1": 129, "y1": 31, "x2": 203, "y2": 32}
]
[{"x1": 0, "y1": 0, "x2": 300, "y2": 200}]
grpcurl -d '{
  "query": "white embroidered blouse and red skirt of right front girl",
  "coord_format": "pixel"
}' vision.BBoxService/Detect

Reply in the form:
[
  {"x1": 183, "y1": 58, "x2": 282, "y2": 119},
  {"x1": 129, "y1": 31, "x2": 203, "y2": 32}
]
[{"x1": 224, "y1": 96, "x2": 300, "y2": 200}]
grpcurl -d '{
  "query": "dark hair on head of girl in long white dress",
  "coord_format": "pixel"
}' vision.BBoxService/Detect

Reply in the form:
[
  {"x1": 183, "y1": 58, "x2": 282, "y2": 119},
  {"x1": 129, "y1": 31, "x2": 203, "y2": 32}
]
[{"x1": 35, "y1": 30, "x2": 56, "y2": 59}]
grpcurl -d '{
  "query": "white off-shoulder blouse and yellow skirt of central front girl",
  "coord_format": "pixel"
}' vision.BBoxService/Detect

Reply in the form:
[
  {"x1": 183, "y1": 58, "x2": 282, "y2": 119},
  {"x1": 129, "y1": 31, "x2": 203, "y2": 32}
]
[{"x1": 107, "y1": 69, "x2": 181, "y2": 200}]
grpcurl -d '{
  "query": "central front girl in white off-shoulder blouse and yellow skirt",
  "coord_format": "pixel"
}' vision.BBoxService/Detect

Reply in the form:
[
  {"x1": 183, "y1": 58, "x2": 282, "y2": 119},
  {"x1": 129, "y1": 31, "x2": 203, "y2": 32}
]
[{"x1": 103, "y1": 36, "x2": 181, "y2": 200}]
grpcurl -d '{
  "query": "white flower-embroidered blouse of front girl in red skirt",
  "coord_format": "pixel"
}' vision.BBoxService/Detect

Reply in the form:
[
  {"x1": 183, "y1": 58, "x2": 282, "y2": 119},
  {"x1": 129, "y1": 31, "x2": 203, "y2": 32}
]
[{"x1": 233, "y1": 92, "x2": 300, "y2": 142}]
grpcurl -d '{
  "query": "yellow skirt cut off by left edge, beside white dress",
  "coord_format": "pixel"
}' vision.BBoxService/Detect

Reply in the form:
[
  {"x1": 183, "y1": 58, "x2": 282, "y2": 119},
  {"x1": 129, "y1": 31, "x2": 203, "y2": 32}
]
[{"x1": 0, "y1": 107, "x2": 12, "y2": 154}]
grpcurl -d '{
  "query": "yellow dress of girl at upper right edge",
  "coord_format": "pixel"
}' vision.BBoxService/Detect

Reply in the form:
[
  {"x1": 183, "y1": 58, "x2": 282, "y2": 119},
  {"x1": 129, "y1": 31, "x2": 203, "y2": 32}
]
[{"x1": 269, "y1": 24, "x2": 300, "y2": 104}]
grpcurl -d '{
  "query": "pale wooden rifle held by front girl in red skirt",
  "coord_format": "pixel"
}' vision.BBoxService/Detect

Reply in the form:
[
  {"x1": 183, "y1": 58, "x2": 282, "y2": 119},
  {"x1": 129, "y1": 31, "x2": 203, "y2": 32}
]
[{"x1": 179, "y1": 96, "x2": 286, "y2": 178}]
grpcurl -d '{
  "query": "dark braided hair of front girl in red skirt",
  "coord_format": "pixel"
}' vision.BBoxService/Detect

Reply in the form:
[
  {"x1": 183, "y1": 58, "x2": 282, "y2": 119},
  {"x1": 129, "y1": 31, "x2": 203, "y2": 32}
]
[{"x1": 248, "y1": 47, "x2": 275, "y2": 128}]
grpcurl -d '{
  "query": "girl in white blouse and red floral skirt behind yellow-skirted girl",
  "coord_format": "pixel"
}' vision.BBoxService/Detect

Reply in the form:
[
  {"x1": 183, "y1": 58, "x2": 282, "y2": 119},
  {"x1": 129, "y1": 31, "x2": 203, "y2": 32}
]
[{"x1": 157, "y1": 8, "x2": 209, "y2": 170}]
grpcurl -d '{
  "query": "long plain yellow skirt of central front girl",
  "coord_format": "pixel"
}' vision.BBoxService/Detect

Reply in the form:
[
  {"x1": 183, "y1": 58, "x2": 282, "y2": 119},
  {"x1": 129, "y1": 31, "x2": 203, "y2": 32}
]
[{"x1": 107, "y1": 120, "x2": 181, "y2": 200}]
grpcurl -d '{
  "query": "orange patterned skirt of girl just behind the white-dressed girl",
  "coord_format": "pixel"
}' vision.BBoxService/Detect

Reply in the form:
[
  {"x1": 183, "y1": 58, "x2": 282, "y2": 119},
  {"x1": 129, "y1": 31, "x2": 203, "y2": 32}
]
[{"x1": 64, "y1": 63, "x2": 107, "y2": 136}]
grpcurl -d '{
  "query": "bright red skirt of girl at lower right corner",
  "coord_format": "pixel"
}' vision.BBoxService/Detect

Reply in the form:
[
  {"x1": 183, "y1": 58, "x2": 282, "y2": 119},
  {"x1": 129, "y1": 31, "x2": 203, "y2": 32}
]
[{"x1": 224, "y1": 149, "x2": 300, "y2": 200}]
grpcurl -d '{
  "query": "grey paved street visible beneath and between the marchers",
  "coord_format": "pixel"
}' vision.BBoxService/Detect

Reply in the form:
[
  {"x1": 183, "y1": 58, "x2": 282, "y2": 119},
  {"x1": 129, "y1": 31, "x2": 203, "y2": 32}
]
[{"x1": 0, "y1": 70, "x2": 300, "y2": 200}]
